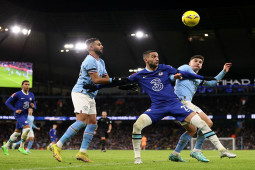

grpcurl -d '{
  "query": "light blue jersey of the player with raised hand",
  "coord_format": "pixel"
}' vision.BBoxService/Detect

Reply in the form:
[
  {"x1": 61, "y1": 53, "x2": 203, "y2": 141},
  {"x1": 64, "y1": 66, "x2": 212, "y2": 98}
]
[{"x1": 170, "y1": 64, "x2": 226, "y2": 101}]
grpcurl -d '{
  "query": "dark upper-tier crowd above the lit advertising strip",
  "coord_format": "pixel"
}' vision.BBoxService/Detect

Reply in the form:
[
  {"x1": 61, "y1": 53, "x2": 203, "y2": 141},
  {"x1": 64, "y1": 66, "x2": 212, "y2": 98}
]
[{"x1": 0, "y1": 95, "x2": 255, "y2": 116}]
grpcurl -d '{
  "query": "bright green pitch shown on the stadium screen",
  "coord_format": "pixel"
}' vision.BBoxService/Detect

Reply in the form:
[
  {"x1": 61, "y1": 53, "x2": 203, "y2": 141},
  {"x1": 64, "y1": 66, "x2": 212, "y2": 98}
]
[{"x1": 0, "y1": 67, "x2": 33, "y2": 88}]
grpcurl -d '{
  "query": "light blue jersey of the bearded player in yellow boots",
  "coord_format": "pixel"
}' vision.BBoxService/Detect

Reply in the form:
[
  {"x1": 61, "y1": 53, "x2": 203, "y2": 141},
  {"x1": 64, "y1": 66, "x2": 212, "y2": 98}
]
[{"x1": 72, "y1": 54, "x2": 107, "y2": 98}]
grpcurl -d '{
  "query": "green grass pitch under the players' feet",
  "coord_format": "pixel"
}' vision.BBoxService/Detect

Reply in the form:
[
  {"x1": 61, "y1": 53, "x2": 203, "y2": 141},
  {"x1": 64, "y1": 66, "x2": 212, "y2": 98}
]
[{"x1": 0, "y1": 149, "x2": 255, "y2": 170}]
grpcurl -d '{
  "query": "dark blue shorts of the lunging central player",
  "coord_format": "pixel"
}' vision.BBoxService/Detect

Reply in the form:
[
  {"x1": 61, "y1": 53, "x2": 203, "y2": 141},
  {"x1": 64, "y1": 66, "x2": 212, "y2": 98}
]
[{"x1": 144, "y1": 99, "x2": 193, "y2": 123}]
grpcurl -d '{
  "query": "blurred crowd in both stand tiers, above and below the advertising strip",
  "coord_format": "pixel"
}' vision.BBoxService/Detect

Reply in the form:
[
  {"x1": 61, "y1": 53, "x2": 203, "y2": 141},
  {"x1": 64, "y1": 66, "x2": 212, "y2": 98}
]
[{"x1": 0, "y1": 95, "x2": 255, "y2": 149}]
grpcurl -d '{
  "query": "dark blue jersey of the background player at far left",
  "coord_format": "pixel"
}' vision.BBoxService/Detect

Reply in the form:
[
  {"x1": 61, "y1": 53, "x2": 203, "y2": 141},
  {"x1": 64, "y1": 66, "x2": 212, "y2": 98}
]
[{"x1": 5, "y1": 90, "x2": 36, "y2": 116}]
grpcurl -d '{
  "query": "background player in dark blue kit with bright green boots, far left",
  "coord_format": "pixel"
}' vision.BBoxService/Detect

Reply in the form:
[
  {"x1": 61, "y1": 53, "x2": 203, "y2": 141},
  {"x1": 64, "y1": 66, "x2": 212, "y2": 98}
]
[{"x1": 2, "y1": 80, "x2": 36, "y2": 155}]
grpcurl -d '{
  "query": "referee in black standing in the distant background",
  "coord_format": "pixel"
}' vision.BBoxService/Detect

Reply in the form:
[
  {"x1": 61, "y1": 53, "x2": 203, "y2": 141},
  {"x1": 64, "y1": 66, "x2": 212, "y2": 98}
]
[{"x1": 95, "y1": 111, "x2": 112, "y2": 152}]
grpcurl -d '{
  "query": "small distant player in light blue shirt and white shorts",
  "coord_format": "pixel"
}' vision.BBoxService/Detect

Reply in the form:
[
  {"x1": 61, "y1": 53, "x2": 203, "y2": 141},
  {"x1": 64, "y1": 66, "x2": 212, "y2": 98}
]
[{"x1": 12, "y1": 108, "x2": 40, "y2": 153}]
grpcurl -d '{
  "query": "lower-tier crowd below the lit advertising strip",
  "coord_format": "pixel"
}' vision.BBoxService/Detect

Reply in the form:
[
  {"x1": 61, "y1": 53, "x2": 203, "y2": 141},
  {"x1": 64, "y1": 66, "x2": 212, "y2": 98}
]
[{"x1": 0, "y1": 120, "x2": 255, "y2": 150}]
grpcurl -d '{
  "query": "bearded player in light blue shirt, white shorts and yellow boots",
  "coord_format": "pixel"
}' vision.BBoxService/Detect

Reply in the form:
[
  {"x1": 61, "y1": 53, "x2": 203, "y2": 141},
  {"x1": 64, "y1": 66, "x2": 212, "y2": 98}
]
[{"x1": 51, "y1": 38, "x2": 124, "y2": 162}]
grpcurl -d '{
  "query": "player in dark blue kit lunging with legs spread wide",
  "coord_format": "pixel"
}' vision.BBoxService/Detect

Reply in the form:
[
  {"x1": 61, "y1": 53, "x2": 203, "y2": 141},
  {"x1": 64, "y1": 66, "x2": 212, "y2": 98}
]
[{"x1": 84, "y1": 50, "x2": 236, "y2": 164}]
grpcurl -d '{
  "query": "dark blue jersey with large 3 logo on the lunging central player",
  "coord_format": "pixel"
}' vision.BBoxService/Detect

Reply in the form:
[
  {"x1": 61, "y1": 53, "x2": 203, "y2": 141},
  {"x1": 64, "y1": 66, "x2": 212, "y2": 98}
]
[{"x1": 128, "y1": 64, "x2": 178, "y2": 105}]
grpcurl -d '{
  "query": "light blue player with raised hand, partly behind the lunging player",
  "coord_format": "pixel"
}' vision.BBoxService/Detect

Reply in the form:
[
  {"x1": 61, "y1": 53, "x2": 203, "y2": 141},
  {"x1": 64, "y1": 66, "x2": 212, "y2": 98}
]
[{"x1": 169, "y1": 55, "x2": 232, "y2": 162}]
